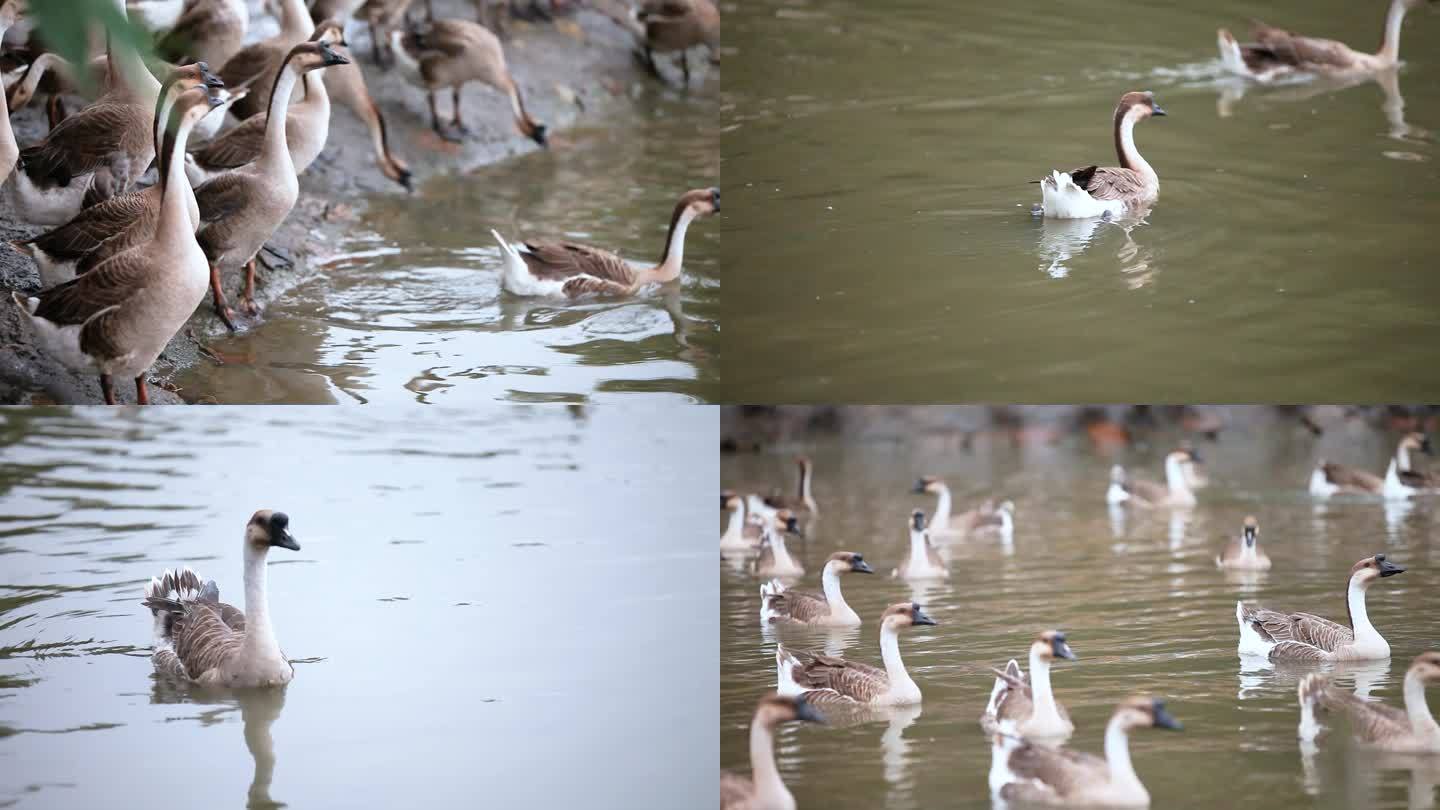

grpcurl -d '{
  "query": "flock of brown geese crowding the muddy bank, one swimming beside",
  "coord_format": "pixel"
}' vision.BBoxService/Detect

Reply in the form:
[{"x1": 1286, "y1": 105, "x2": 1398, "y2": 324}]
[{"x1": 0, "y1": 0, "x2": 720, "y2": 404}]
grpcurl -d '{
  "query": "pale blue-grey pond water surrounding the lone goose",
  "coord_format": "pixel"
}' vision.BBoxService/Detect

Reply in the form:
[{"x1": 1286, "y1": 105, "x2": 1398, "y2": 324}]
[{"x1": 0, "y1": 404, "x2": 719, "y2": 809}]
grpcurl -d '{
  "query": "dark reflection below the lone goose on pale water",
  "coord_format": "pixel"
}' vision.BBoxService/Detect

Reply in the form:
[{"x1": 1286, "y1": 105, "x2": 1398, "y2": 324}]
[{"x1": 150, "y1": 677, "x2": 288, "y2": 810}]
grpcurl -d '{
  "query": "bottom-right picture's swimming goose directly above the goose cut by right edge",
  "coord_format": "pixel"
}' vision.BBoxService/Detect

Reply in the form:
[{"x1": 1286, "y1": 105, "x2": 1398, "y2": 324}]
[{"x1": 1236, "y1": 553, "x2": 1405, "y2": 662}]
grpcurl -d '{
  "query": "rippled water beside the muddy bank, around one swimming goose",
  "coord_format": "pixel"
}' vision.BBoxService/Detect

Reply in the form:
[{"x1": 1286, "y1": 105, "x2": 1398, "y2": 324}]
[{"x1": 180, "y1": 82, "x2": 720, "y2": 405}]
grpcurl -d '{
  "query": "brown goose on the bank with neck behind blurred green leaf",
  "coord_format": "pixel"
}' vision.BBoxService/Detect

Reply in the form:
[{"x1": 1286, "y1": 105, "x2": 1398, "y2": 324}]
[{"x1": 4, "y1": 0, "x2": 160, "y2": 225}]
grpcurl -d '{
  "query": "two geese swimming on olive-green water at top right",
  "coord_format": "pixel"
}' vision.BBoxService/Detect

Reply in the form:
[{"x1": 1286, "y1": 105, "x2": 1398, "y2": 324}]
[{"x1": 1034, "y1": 0, "x2": 1436, "y2": 219}]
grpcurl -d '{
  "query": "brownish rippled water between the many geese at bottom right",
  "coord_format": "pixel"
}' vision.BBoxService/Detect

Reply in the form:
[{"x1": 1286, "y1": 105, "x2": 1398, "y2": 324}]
[{"x1": 720, "y1": 425, "x2": 1440, "y2": 810}]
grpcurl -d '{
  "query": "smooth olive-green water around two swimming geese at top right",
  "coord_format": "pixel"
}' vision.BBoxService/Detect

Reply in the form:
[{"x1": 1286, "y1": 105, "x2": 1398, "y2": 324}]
[{"x1": 721, "y1": 0, "x2": 1440, "y2": 402}]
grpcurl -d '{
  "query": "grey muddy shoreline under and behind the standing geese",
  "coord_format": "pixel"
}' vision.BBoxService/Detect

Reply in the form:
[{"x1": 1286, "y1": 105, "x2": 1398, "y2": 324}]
[{"x1": 0, "y1": 0, "x2": 699, "y2": 405}]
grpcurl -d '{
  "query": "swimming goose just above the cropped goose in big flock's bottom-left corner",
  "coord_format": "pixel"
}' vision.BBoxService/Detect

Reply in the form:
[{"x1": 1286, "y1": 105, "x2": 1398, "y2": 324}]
[{"x1": 775, "y1": 602, "x2": 935, "y2": 708}]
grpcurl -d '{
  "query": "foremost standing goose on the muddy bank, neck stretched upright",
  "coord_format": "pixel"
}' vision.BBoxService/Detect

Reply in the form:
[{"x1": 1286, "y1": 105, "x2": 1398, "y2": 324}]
[{"x1": 12, "y1": 88, "x2": 217, "y2": 405}]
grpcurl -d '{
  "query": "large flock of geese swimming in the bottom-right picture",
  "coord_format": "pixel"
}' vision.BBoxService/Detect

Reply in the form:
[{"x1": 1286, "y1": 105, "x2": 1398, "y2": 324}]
[{"x1": 720, "y1": 432, "x2": 1440, "y2": 810}]
